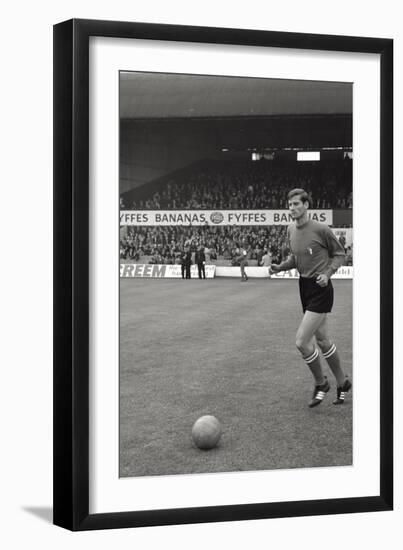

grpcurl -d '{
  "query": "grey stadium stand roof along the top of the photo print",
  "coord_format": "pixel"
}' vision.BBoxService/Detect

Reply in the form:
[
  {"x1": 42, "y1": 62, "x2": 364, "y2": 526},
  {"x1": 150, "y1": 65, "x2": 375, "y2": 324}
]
[{"x1": 120, "y1": 72, "x2": 352, "y2": 119}]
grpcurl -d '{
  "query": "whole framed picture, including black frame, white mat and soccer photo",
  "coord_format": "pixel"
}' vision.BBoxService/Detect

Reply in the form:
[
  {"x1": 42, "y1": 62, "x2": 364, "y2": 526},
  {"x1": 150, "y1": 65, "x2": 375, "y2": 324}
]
[{"x1": 53, "y1": 12, "x2": 393, "y2": 530}]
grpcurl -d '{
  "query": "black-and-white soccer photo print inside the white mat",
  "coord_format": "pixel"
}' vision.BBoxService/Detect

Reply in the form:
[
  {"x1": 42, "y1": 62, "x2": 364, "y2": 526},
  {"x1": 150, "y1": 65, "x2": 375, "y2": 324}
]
[{"x1": 116, "y1": 71, "x2": 355, "y2": 478}]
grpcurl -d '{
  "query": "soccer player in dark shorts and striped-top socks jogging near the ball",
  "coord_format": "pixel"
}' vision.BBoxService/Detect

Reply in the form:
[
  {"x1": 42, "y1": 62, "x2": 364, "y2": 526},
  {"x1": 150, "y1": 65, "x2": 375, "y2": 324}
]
[{"x1": 271, "y1": 189, "x2": 351, "y2": 407}]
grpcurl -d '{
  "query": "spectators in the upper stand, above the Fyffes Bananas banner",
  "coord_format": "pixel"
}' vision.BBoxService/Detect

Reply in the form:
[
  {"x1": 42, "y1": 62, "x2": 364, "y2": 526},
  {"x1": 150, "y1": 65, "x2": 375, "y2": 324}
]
[{"x1": 121, "y1": 160, "x2": 353, "y2": 210}]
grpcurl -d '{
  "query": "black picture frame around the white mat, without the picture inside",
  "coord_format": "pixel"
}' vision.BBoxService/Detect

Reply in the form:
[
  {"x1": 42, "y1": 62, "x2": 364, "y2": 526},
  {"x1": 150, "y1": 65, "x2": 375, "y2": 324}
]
[{"x1": 54, "y1": 19, "x2": 393, "y2": 531}]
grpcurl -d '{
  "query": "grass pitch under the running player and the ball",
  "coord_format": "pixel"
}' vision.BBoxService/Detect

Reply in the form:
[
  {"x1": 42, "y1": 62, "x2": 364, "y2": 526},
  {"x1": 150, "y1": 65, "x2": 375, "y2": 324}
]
[{"x1": 120, "y1": 279, "x2": 352, "y2": 477}]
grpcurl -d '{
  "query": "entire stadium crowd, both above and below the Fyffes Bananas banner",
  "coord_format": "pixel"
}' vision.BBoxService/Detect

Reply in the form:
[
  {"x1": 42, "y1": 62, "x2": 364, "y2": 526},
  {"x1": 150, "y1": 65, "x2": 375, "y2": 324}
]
[{"x1": 120, "y1": 159, "x2": 352, "y2": 265}]
